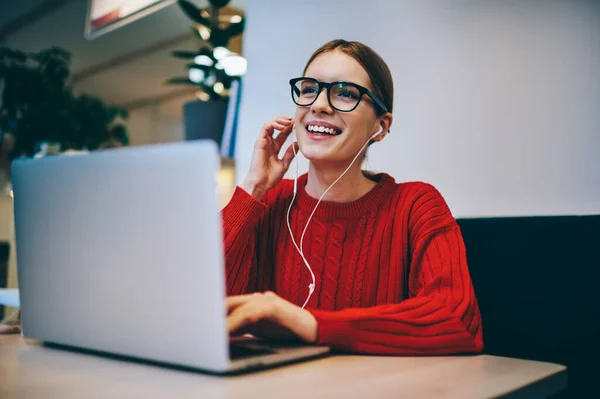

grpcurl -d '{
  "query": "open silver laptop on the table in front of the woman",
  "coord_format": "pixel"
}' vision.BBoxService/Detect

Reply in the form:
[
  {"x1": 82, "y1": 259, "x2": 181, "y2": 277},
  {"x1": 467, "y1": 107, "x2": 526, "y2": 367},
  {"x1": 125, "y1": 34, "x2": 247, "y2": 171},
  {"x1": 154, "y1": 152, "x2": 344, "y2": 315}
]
[{"x1": 12, "y1": 141, "x2": 328, "y2": 373}]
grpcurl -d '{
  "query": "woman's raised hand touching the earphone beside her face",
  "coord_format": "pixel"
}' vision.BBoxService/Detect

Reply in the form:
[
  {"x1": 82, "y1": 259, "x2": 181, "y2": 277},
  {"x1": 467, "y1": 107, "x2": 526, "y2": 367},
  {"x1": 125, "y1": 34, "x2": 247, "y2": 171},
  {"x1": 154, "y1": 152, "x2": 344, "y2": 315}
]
[{"x1": 240, "y1": 116, "x2": 298, "y2": 200}]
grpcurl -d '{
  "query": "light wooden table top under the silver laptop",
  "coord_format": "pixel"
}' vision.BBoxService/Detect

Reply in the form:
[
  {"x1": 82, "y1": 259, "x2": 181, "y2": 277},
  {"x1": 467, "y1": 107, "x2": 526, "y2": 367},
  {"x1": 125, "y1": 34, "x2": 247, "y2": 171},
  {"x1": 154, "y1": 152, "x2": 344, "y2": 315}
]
[{"x1": 0, "y1": 335, "x2": 567, "y2": 399}]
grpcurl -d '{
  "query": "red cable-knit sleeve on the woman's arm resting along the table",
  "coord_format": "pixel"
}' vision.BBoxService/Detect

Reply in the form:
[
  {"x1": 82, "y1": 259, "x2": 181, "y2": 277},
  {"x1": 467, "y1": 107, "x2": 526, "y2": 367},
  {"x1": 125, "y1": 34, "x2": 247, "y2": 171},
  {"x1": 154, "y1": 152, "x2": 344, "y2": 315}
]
[{"x1": 310, "y1": 185, "x2": 483, "y2": 355}]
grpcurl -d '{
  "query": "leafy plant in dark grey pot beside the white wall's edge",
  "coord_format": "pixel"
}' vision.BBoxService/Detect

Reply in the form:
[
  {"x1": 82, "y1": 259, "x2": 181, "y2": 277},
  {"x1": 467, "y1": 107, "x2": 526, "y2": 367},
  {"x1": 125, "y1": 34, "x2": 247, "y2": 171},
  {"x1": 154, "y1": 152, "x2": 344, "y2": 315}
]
[{"x1": 166, "y1": 0, "x2": 246, "y2": 157}]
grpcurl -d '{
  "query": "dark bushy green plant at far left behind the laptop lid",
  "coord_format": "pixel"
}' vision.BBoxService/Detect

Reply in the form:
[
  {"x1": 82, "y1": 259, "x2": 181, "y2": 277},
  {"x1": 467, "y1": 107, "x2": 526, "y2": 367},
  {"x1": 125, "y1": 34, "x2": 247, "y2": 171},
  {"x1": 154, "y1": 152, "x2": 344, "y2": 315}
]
[{"x1": 0, "y1": 47, "x2": 128, "y2": 159}]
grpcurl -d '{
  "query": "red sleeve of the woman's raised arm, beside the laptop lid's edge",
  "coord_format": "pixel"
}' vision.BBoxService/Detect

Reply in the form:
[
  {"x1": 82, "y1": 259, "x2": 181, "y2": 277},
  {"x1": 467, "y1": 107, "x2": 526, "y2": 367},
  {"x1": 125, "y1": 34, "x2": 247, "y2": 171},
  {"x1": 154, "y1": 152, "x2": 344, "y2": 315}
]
[{"x1": 221, "y1": 187, "x2": 266, "y2": 295}]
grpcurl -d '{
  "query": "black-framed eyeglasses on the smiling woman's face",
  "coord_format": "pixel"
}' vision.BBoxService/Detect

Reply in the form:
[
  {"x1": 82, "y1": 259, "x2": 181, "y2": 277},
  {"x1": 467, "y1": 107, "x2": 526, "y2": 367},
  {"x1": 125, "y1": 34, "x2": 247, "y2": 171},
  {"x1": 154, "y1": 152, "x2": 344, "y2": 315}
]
[{"x1": 290, "y1": 78, "x2": 388, "y2": 114}]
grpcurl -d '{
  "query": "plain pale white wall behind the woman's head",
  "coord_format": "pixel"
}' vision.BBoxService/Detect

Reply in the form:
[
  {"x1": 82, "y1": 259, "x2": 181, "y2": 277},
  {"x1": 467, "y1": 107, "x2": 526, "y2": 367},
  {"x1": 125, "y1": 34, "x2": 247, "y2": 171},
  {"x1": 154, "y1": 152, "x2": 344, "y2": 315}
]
[{"x1": 236, "y1": 0, "x2": 600, "y2": 217}]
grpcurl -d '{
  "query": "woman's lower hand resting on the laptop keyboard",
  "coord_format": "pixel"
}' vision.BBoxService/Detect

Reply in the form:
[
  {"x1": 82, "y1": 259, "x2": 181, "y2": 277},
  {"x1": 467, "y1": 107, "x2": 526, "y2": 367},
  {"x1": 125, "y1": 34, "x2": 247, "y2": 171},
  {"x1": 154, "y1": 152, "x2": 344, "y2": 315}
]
[{"x1": 227, "y1": 292, "x2": 317, "y2": 343}]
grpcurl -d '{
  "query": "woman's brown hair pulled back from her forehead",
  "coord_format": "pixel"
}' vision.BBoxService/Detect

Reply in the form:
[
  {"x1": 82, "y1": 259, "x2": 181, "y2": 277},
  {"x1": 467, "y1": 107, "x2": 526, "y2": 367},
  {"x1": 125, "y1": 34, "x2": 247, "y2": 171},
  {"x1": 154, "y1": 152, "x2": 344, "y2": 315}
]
[{"x1": 302, "y1": 39, "x2": 394, "y2": 113}]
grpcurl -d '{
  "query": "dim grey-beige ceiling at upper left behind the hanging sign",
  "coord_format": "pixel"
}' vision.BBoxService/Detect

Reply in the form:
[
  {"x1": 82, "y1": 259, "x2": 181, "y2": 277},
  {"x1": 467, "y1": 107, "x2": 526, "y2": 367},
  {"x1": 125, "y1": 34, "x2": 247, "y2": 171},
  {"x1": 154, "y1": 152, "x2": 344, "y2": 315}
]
[{"x1": 0, "y1": 0, "x2": 246, "y2": 109}]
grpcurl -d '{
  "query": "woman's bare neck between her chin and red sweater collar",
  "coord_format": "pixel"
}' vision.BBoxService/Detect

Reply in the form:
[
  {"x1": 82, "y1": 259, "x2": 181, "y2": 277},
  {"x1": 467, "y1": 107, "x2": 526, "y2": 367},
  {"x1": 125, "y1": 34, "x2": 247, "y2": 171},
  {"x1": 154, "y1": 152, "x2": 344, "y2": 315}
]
[{"x1": 305, "y1": 160, "x2": 376, "y2": 202}]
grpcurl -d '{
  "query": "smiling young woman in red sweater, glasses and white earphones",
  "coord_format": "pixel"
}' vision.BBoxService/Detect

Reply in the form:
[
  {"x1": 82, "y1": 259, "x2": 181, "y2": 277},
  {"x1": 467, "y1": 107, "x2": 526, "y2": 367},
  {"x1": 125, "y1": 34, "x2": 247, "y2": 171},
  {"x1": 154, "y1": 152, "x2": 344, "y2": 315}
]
[{"x1": 222, "y1": 40, "x2": 483, "y2": 355}]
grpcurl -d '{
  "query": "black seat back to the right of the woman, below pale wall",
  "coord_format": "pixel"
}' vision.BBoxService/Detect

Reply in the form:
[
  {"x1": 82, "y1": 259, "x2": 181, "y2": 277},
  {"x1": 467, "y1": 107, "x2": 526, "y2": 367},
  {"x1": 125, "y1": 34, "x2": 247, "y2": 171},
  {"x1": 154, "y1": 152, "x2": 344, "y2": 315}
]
[{"x1": 458, "y1": 215, "x2": 600, "y2": 397}]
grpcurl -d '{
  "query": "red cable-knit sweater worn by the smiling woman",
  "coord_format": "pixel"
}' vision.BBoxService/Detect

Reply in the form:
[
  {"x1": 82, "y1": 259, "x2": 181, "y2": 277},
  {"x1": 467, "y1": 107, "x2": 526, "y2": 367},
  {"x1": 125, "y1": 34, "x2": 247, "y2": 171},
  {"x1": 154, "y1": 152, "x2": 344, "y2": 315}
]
[{"x1": 222, "y1": 174, "x2": 483, "y2": 355}]
